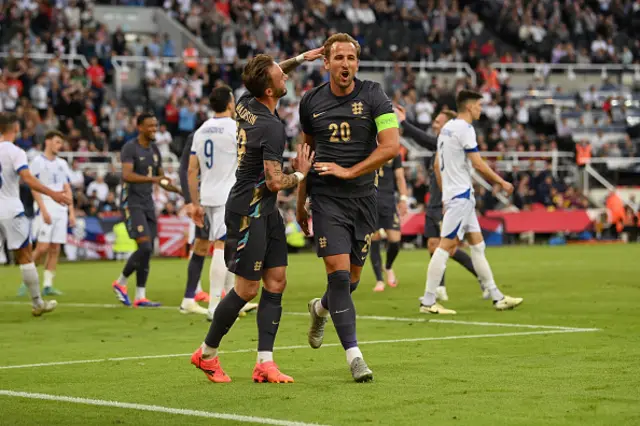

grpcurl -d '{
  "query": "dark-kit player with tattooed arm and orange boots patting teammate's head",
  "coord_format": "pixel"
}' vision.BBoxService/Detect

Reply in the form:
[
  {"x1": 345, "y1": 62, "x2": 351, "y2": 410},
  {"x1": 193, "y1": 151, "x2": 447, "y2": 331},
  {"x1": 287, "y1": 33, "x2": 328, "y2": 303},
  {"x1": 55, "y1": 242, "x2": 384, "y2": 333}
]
[{"x1": 191, "y1": 49, "x2": 322, "y2": 383}]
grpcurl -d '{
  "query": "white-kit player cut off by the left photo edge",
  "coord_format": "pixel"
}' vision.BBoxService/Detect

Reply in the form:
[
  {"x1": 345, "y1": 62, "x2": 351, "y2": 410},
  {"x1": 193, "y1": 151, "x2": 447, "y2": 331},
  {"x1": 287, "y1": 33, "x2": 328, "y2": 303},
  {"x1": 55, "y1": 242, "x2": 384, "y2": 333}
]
[{"x1": 0, "y1": 113, "x2": 73, "y2": 316}]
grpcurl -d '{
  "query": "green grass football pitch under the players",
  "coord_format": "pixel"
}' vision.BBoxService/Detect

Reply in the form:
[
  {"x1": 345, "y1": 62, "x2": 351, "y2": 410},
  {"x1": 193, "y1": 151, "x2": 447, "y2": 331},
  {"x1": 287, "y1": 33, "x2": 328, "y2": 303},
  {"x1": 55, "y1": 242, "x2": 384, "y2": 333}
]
[{"x1": 0, "y1": 245, "x2": 640, "y2": 426}]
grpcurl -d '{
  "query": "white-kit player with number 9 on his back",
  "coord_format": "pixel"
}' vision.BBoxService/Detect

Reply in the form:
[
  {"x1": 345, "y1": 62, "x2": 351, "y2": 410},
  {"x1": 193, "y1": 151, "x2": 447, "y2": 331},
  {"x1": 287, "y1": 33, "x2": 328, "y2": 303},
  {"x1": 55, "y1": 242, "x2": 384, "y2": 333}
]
[{"x1": 181, "y1": 86, "x2": 257, "y2": 320}]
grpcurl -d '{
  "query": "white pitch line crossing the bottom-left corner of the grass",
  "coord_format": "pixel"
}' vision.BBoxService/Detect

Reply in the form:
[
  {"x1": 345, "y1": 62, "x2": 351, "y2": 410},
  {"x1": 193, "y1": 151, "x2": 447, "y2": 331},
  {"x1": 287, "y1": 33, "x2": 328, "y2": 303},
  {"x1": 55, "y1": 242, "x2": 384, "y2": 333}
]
[{"x1": 0, "y1": 389, "x2": 330, "y2": 426}]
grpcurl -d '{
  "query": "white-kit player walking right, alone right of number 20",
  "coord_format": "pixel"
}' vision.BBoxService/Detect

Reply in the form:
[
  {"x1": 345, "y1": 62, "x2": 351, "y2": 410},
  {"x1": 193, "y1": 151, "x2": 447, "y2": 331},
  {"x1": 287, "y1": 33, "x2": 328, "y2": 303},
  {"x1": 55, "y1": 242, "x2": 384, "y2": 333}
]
[{"x1": 420, "y1": 90, "x2": 522, "y2": 314}]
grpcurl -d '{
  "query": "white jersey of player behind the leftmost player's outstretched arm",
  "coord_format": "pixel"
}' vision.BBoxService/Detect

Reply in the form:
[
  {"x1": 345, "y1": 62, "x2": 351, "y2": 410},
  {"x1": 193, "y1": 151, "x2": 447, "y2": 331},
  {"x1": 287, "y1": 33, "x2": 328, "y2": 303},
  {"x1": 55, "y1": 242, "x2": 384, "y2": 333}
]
[{"x1": 29, "y1": 154, "x2": 71, "y2": 218}]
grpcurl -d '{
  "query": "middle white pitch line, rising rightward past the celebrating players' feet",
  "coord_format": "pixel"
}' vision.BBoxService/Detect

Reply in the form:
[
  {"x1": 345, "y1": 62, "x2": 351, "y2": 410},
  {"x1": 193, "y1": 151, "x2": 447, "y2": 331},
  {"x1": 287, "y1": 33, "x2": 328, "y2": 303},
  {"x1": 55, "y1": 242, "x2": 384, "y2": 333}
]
[{"x1": 0, "y1": 328, "x2": 598, "y2": 370}]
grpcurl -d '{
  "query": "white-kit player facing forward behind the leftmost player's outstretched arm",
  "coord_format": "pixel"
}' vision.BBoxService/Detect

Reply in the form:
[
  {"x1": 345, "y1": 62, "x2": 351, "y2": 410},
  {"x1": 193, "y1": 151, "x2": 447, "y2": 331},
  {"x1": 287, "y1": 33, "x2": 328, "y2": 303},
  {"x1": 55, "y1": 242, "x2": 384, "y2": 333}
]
[{"x1": 18, "y1": 130, "x2": 76, "y2": 296}]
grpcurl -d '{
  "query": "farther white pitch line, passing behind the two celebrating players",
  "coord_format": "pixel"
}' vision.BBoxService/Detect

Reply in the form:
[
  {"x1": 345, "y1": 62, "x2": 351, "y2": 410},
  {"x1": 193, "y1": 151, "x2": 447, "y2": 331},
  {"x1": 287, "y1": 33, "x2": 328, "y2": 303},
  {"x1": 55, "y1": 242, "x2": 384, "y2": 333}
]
[{"x1": 0, "y1": 301, "x2": 598, "y2": 331}]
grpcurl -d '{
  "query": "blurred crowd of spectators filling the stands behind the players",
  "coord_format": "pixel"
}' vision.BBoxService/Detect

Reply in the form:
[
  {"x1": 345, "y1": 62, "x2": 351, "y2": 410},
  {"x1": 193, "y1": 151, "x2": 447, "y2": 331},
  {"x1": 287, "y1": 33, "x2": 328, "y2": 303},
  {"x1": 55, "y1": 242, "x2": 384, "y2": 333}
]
[{"x1": 0, "y1": 0, "x2": 640, "y2": 233}]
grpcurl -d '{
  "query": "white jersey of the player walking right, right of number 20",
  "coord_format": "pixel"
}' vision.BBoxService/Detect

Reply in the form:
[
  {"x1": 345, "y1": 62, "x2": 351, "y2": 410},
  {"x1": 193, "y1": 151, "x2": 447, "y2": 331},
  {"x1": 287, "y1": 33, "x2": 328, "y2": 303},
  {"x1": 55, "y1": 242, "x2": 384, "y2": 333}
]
[{"x1": 438, "y1": 119, "x2": 478, "y2": 201}]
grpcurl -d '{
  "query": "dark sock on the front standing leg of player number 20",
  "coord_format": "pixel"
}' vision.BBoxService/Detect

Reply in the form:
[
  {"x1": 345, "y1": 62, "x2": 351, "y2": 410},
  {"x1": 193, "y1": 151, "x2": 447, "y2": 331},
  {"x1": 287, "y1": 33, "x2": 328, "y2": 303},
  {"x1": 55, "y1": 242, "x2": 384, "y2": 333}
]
[{"x1": 327, "y1": 271, "x2": 358, "y2": 350}]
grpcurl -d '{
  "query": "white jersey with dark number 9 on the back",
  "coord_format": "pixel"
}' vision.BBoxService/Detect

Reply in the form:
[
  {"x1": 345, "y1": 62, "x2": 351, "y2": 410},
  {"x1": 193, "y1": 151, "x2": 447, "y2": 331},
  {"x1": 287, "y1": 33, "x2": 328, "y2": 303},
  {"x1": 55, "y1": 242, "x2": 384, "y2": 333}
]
[{"x1": 191, "y1": 117, "x2": 238, "y2": 207}]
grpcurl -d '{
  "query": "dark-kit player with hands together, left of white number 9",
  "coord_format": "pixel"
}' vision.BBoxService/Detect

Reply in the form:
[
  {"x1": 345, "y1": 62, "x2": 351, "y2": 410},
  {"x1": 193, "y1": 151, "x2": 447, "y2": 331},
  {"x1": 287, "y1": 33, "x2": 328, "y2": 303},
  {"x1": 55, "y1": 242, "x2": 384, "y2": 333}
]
[{"x1": 111, "y1": 113, "x2": 180, "y2": 308}]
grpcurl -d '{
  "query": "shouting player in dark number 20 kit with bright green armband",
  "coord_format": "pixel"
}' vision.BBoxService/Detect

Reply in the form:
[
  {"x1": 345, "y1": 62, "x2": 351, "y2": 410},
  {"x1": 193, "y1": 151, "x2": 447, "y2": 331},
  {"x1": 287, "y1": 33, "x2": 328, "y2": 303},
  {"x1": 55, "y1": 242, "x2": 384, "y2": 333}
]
[{"x1": 296, "y1": 34, "x2": 400, "y2": 382}]
